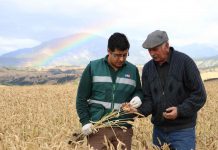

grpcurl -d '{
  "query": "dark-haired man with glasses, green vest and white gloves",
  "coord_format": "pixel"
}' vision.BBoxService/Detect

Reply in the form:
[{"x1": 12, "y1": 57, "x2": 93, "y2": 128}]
[{"x1": 76, "y1": 33, "x2": 142, "y2": 150}]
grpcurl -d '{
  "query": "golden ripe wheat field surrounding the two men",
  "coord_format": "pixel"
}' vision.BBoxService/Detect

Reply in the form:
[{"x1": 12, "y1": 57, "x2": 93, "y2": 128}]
[{"x1": 0, "y1": 81, "x2": 218, "y2": 150}]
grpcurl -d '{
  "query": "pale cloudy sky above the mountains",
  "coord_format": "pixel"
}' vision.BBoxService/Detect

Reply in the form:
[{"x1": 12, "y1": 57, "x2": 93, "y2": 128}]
[{"x1": 0, "y1": 0, "x2": 218, "y2": 55}]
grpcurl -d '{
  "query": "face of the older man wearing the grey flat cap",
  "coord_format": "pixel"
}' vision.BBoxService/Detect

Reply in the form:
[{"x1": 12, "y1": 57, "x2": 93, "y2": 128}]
[{"x1": 148, "y1": 43, "x2": 169, "y2": 64}]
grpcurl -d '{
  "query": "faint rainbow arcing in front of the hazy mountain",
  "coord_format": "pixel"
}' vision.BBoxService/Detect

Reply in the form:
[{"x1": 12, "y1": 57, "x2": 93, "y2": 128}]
[{"x1": 33, "y1": 21, "x2": 117, "y2": 67}]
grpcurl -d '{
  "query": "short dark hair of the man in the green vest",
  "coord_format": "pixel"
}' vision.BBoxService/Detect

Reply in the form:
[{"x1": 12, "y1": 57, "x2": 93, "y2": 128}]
[{"x1": 108, "y1": 32, "x2": 130, "y2": 52}]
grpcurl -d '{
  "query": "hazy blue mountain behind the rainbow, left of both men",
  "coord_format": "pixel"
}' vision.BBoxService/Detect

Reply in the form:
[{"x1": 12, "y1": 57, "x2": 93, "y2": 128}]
[{"x1": 0, "y1": 33, "x2": 107, "y2": 67}]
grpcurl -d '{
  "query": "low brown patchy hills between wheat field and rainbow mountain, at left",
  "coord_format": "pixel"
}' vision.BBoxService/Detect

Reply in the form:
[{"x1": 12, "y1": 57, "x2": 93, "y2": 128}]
[{"x1": 0, "y1": 66, "x2": 84, "y2": 85}]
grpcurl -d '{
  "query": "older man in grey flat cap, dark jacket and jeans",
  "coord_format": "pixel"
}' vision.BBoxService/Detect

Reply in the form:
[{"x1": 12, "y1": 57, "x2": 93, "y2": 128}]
[{"x1": 138, "y1": 30, "x2": 206, "y2": 150}]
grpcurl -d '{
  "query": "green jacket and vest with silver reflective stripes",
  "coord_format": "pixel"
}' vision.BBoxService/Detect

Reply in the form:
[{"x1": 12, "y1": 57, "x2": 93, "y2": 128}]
[{"x1": 76, "y1": 56, "x2": 142, "y2": 125}]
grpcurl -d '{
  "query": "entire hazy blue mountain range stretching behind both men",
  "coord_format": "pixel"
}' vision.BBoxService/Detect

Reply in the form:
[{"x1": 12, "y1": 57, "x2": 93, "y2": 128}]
[{"x1": 0, "y1": 33, "x2": 218, "y2": 68}]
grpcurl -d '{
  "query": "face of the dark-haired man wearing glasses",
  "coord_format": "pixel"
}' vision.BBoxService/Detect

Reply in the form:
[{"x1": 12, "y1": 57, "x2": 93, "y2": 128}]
[{"x1": 108, "y1": 49, "x2": 129, "y2": 70}]
